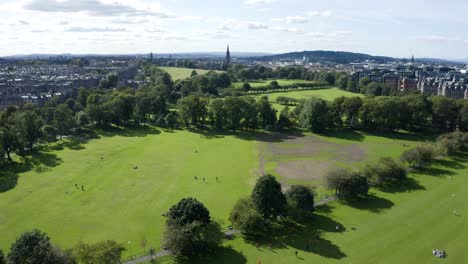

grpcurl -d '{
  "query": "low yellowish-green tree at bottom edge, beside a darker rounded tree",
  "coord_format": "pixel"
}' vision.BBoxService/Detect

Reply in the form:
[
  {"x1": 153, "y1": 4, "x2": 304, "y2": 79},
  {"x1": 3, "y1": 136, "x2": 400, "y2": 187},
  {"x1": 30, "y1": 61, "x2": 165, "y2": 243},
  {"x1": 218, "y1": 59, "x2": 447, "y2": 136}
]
[{"x1": 73, "y1": 240, "x2": 125, "y2": 264}]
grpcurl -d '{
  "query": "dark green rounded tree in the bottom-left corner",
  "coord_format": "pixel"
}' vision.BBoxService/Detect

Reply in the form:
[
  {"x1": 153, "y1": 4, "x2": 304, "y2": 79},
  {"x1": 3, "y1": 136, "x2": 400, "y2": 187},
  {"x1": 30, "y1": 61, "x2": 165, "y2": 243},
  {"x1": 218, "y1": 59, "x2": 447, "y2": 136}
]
[{"x1": 7, "y1": 229, "x2": 58, "y2": 264}]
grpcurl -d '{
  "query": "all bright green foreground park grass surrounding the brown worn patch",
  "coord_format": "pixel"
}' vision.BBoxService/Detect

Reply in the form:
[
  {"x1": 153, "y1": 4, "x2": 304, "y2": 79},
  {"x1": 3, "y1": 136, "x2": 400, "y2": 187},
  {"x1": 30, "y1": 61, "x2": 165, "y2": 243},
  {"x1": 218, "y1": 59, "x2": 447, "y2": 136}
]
[{"x1": 0, "y1": 129, "x2": 468, "y2": 263}]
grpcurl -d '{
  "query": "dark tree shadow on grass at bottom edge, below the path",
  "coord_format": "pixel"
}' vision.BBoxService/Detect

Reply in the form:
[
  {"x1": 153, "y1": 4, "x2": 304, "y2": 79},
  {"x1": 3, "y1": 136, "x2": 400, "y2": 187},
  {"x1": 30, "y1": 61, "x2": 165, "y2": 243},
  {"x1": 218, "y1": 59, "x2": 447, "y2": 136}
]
[{"x1": 175, "y1": 247, "x2": 247, "y2": 264}]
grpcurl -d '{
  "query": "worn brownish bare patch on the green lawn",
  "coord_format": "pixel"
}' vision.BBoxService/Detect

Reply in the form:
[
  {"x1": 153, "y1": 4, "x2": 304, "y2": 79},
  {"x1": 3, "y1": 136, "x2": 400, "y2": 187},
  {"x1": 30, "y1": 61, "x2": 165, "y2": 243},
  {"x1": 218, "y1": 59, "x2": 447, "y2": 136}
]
[{"x1": 259, "y1": 133, "x2": 367, "y2": 180}]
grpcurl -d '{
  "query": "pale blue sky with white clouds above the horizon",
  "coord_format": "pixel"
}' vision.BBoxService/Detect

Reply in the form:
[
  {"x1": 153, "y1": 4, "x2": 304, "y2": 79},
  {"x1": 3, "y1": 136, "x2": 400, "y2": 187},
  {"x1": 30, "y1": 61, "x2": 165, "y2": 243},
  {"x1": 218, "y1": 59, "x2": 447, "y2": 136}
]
[{"x1": 0, "y1": 0, "x2": 468, "y2": 59}]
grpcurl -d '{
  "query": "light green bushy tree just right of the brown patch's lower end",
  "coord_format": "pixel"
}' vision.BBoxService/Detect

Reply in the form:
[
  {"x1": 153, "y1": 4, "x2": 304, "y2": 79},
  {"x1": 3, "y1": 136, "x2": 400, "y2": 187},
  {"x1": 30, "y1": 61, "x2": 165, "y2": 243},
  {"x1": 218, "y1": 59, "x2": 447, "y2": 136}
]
[{"x1": 362, "y1": 157, "x2": 407, "y2": 185}]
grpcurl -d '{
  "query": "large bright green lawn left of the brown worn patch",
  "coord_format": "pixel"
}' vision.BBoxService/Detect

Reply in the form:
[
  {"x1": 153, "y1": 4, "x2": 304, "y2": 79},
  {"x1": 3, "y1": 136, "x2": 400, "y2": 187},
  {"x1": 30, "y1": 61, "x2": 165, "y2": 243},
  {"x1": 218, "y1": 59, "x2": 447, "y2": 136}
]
[{"x1": 0, "y1": 129, "x2": 258, "y2": 256}]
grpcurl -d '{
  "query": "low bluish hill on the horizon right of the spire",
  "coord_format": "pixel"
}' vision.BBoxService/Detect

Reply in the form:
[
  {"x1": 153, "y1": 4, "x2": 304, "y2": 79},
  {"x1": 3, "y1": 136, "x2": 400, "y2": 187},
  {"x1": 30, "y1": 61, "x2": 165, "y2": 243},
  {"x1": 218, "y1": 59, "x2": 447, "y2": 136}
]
[{"x1": 251, "y1": 50, "x2": 396, "y2": 63}]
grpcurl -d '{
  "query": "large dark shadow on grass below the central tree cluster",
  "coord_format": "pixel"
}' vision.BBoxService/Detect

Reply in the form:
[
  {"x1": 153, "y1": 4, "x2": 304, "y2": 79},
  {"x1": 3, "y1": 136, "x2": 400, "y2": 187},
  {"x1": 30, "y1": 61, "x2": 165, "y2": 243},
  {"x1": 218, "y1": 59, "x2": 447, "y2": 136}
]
[{"x1": 244, "y1": 214, "x2": 346, "y2": 259}]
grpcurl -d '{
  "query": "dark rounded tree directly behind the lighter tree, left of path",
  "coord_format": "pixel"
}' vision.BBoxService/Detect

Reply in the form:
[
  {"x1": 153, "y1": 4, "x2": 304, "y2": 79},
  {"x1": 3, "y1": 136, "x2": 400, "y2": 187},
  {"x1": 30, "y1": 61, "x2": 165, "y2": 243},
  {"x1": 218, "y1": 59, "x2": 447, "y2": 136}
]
[{"x1": 167, "y1": 198, "x2": 211, "y2": 226}]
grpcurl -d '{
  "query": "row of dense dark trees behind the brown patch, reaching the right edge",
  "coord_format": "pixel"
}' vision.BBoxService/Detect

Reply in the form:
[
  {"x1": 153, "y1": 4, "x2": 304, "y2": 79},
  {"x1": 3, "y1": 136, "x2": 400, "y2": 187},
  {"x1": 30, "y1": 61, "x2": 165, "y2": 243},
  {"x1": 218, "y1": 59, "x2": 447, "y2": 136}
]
[{"x1": 295, "y1": 95, "x2": 468, "y2": 132}]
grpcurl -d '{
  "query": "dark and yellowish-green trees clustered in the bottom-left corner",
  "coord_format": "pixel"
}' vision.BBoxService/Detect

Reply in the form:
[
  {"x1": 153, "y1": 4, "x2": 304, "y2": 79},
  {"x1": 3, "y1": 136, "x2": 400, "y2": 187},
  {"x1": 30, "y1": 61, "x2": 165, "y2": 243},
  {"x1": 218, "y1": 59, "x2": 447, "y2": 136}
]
[{"x1": 0, "y1": 229, "x2": 125, "y2": 264}]
